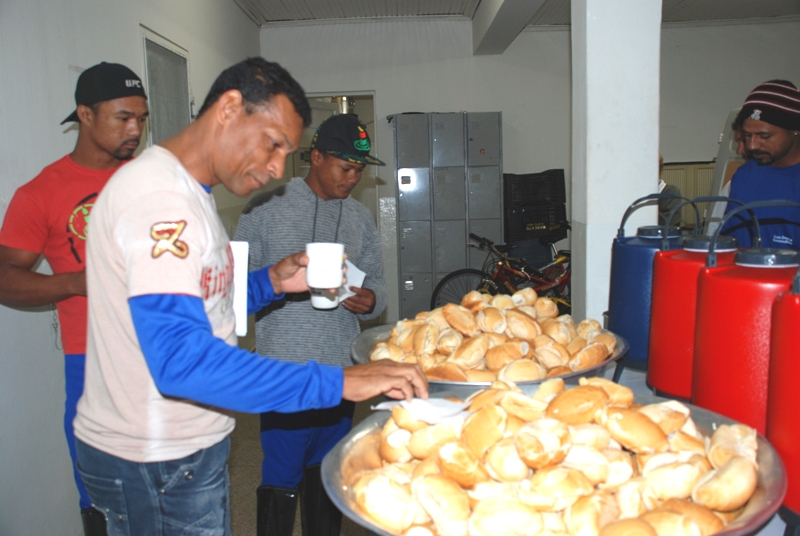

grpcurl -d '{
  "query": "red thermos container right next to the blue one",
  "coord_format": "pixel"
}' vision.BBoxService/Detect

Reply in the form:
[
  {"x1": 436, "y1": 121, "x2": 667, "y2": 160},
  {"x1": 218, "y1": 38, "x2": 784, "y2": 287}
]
[{"x1": 647, "y1": 236, "x2": 737, "y2": 400}]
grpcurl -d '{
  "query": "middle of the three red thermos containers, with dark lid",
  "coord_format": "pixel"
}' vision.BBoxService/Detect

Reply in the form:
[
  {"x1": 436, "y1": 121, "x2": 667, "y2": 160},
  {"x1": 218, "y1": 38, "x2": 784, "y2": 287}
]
[{"x1": 692, "y1": 249, "x2": 800, "y2": 434}]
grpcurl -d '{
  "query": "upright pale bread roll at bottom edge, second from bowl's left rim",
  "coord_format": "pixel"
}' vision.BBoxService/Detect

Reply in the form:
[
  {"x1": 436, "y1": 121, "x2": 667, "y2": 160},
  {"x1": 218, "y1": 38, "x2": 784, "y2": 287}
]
[{"x1": 411, "y1": 475, "x2": 470, "y2": 536}]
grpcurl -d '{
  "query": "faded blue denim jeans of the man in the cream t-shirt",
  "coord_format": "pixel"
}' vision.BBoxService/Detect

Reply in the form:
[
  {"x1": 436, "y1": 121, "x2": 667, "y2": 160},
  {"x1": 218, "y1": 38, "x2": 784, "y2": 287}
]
[{"x1": 77, "y1": 438, "x2": 231, "y2": 536}]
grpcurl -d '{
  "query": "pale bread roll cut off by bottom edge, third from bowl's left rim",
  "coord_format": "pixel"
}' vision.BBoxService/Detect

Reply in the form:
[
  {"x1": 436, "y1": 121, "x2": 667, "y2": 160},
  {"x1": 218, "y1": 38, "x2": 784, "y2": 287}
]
[{"x1": 469, "y1": 497, "x2": 542, "y2": 536}]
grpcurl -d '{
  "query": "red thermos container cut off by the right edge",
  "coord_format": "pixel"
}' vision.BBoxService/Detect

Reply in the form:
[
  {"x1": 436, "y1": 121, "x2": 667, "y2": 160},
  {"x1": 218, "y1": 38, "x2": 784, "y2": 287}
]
[{"x1": 766, "y1": 274, "x2": 800, "y2": 512}]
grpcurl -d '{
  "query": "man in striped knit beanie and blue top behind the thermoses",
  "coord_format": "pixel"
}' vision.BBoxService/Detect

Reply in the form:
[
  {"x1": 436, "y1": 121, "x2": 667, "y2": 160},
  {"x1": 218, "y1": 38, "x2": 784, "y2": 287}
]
[{"x1": 722, "y1": 80, "x2": 800, "y2": 249}]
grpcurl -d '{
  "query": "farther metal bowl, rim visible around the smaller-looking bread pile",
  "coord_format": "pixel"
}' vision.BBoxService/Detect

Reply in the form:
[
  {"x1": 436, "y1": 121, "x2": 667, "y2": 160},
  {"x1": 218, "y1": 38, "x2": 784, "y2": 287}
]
[{"x1": 350, "y1": 324, "x2": 628, "y2": 397}]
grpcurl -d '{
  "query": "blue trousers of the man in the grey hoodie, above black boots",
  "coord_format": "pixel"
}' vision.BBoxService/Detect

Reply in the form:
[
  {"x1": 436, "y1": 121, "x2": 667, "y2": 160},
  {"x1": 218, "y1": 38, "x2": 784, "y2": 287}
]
[{"x1": 261, "y1": 400, "x2": 356, "y2": 489}]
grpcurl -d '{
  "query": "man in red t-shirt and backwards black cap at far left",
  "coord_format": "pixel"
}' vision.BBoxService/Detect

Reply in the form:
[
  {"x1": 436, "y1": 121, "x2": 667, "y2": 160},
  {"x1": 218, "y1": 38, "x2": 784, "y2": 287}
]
[{"x1": 0, "y1": 62, "x2": 148, "y2": 536}]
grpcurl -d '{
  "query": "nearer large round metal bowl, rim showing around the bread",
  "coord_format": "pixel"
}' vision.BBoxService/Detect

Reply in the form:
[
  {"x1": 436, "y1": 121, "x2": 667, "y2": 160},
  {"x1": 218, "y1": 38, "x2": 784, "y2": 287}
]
[{"x1": 322, "y1": 392, "x2": 787, "y2": 536}]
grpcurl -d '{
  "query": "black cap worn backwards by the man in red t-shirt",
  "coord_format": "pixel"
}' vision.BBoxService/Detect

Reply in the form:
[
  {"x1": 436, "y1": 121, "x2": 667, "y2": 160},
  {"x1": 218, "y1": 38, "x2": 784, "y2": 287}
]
[{"x1": 61, "y1": 62, "x2": 147, "y2": 125}]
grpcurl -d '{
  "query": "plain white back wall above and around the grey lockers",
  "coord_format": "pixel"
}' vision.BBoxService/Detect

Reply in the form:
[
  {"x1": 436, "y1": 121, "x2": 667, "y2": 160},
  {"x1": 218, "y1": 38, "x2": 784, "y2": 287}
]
[{"x1": 261, "y1": 16, "x2": 800, "y2": 320}]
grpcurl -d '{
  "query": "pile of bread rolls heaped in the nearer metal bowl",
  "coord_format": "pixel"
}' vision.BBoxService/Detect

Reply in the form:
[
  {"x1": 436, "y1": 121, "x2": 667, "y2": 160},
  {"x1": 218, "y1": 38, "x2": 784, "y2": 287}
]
[{"x1": 348, "y1": 378, "x2": 758, "y2": 536}]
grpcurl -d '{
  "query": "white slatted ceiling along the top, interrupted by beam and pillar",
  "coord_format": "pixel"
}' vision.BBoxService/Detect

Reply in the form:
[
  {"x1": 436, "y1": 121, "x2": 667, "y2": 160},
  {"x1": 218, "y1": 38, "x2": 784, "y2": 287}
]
[{"x1": 233, "y1": 0, "x2": 800, "y2": 27}]
